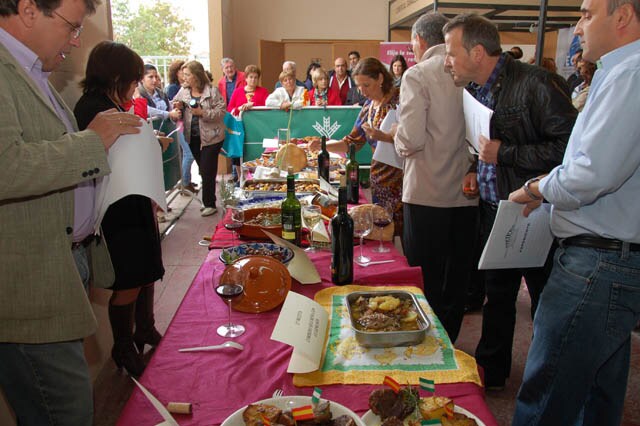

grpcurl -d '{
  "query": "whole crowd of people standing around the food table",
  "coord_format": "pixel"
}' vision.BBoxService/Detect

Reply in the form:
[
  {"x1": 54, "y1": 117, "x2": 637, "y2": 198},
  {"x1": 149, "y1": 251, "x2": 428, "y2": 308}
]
[{"x1": 0, "y1": 0, "x2": 640, "y2": 425}]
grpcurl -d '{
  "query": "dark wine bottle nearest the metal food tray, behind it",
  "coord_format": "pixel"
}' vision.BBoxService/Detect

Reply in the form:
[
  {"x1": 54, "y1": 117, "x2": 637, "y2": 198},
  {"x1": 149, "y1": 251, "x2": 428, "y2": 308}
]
[{"x1": 331, "y1": 187, "x2": 353, "y2": 285}]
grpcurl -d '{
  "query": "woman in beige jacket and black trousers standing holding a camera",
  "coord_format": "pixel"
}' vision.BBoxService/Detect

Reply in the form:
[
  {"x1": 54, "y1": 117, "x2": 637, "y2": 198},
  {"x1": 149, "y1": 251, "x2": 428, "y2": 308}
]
[{"x1": 173, "y1": 61, "x2": 227, "y2": 216}]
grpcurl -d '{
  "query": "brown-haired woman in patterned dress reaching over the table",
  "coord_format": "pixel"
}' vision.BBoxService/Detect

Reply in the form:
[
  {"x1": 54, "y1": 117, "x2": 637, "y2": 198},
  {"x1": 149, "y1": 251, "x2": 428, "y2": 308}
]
[{"x1": 310, "y1": 57, "x2": 403, "y2": 235}]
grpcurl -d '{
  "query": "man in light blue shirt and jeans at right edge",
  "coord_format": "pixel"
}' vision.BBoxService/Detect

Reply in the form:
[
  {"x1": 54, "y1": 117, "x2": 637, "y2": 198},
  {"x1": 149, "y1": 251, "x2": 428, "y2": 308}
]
[{"x1": 510, "y1": 0, "x2": 640, "y2": 425}]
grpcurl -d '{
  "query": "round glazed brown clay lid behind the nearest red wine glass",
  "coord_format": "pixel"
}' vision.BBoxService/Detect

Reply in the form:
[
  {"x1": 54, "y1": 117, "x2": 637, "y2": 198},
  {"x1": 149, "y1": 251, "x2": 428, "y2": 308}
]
[{"x1": 220, "y1": 256, "x2": 291, "y2": 314}]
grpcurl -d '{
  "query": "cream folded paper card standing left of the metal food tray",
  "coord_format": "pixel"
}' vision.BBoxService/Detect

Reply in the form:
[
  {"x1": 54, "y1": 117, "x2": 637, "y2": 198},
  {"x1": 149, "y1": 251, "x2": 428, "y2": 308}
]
[{"x1": 271, "y1": 291, "x2": 329, "y2": 373}]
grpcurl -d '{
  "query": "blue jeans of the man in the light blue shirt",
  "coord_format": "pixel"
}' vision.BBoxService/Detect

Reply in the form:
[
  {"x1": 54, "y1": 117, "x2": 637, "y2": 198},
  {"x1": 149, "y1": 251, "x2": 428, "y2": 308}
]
[{"x1": 513, "y1": 246, "x2": 640, "y2": 426}]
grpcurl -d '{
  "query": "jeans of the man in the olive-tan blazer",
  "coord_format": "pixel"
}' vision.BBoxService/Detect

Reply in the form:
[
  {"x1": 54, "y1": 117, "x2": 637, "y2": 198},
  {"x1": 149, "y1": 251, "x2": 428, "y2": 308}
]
[{"x1": 0, "y1": 340, "x2": 93, "y2": 425}]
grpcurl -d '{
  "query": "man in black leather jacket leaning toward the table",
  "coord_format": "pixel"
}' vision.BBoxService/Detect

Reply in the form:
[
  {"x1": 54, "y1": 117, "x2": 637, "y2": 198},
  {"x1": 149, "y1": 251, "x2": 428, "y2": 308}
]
[{"x1": 444, "y1": 14, "x2": 577, "y2": 390}]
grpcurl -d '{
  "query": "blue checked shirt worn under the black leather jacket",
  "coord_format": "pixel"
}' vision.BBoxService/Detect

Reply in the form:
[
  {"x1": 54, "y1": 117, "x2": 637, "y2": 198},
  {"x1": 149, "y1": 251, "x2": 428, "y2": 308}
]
[{"x1": 467, "y1": 53, "x2": 506, "y2": 204}]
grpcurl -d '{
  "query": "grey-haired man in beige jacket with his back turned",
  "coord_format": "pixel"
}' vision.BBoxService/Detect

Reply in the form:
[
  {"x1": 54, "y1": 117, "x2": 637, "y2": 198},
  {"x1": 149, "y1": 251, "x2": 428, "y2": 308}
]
[{"x1": 395, "y1": 13, "x2": 478, "y2": 341}]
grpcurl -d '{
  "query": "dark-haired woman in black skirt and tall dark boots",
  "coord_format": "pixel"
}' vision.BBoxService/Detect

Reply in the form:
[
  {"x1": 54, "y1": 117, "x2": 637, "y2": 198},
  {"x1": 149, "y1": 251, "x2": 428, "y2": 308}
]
[{"x1": 74, "y1": 41, "x2": 164, "y2": 376}]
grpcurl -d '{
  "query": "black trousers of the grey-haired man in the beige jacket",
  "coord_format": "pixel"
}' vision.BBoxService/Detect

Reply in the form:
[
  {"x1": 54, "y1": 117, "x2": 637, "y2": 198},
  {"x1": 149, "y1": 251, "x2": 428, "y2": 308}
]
[{"x1": 403, "y1": 203, "x2": 478, "y2": 342}]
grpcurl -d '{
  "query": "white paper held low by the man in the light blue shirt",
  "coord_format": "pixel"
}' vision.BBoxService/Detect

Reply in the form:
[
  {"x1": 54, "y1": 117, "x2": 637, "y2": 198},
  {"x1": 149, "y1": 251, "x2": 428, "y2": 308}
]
[{"x1": 478, "y1": 200, "x2": 553, "y2": 269}]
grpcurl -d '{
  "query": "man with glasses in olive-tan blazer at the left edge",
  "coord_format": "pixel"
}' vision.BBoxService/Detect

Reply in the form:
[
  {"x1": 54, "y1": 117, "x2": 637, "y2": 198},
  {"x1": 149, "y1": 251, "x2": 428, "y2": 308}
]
[{"x1": 0, "y1": 0, "x2": 141, "y2": 425}]
